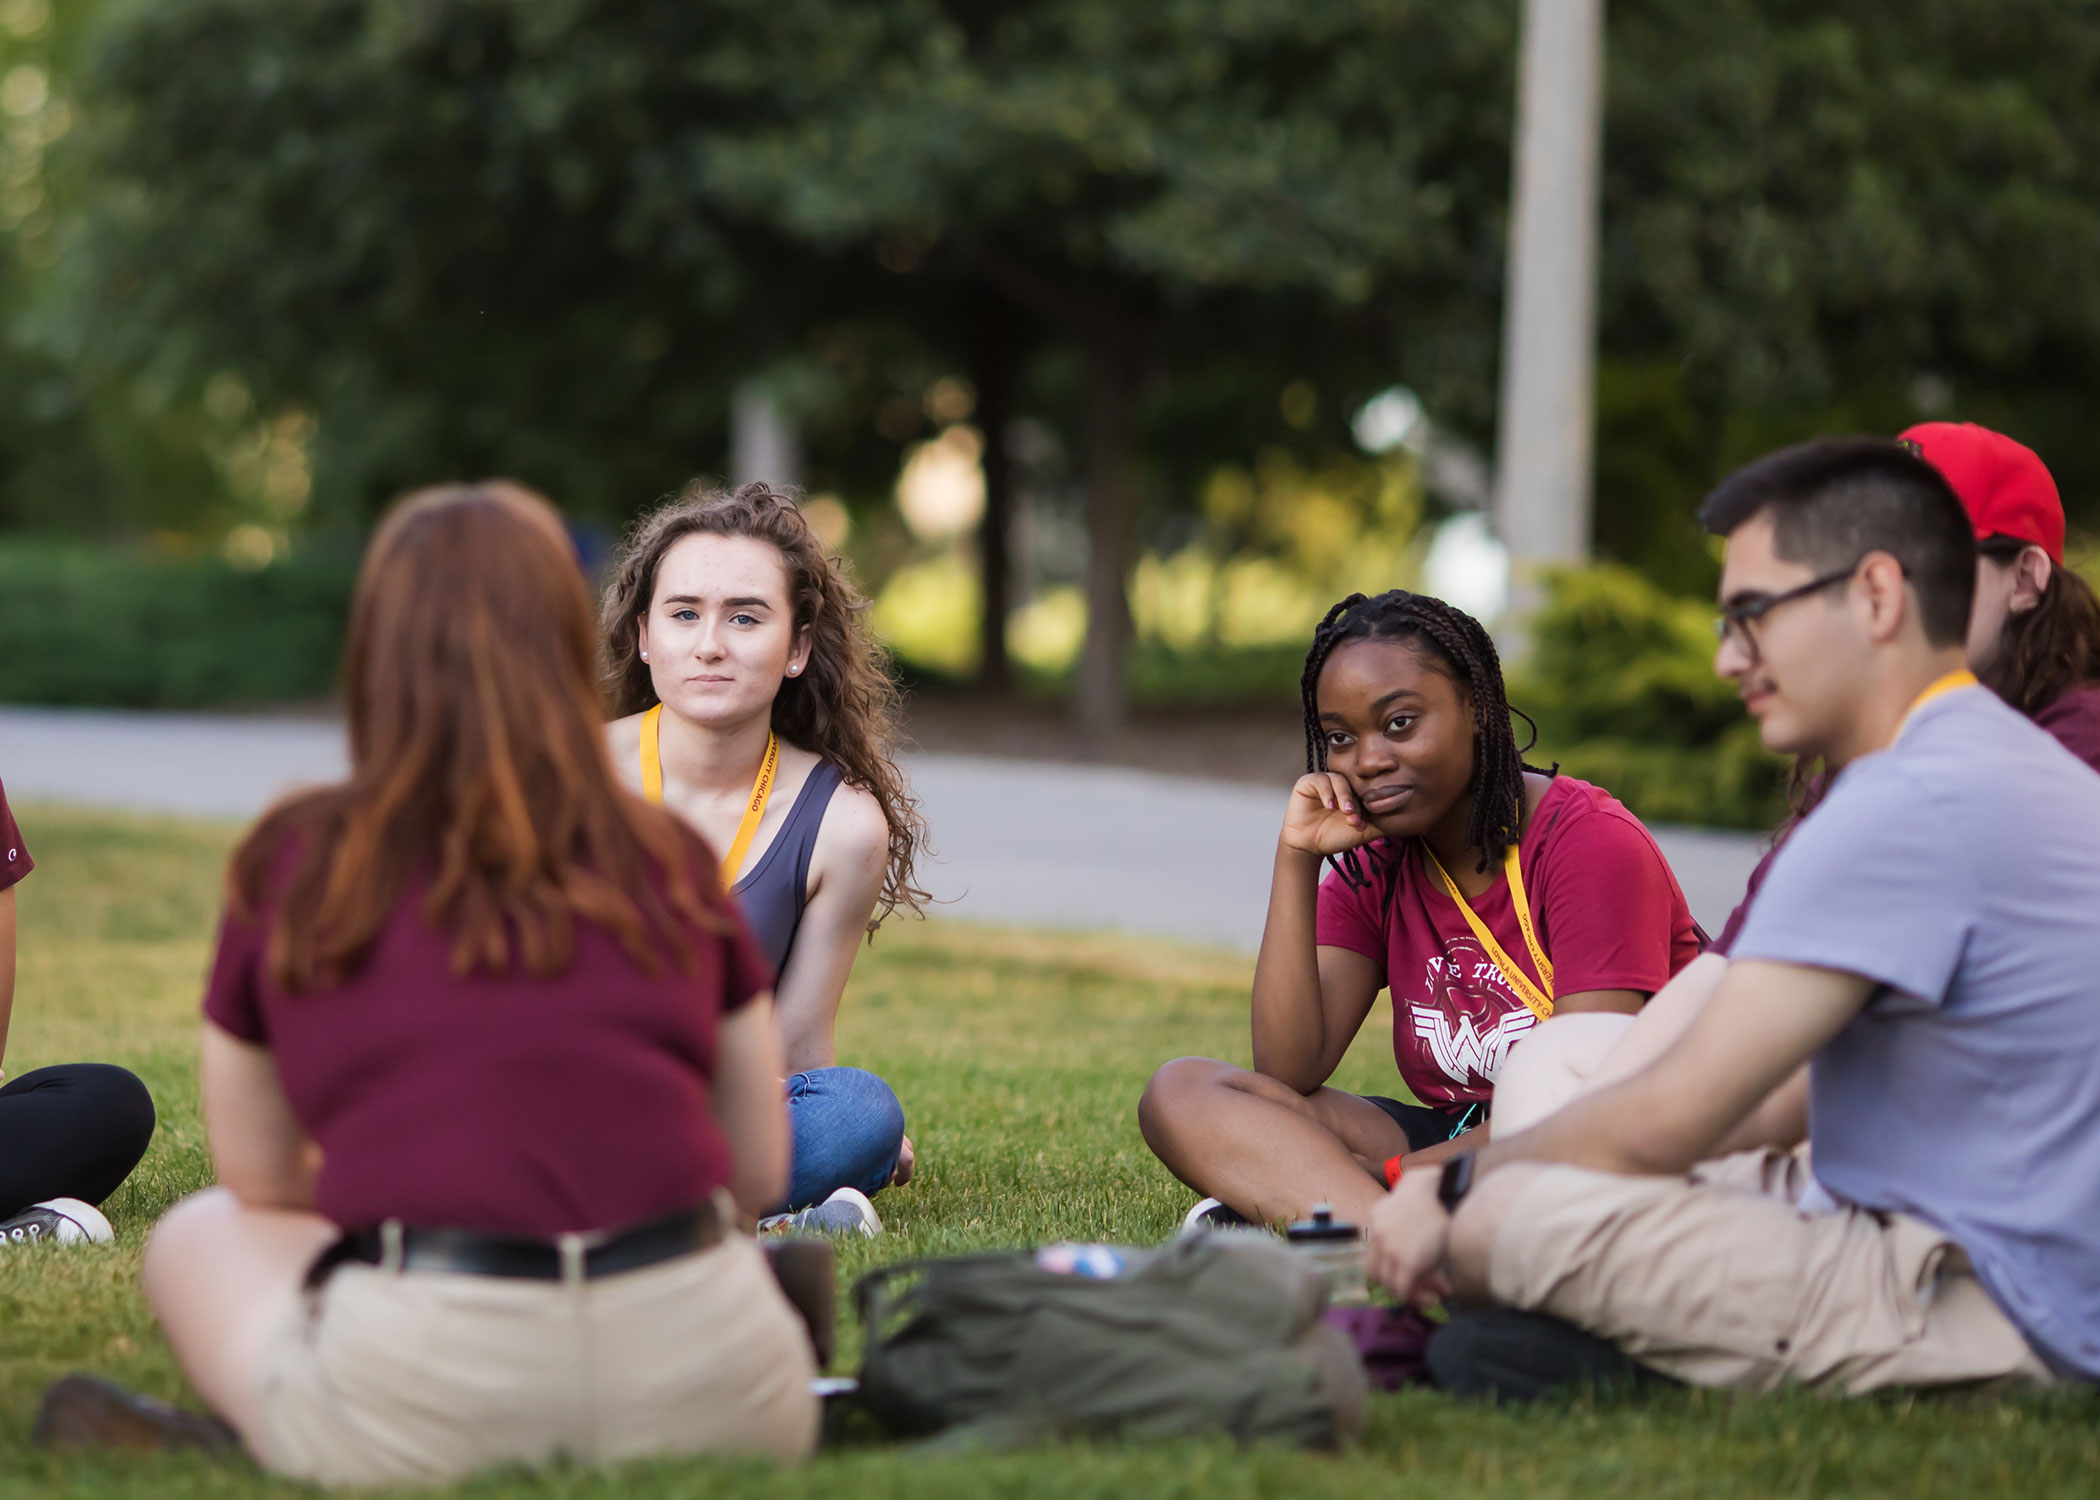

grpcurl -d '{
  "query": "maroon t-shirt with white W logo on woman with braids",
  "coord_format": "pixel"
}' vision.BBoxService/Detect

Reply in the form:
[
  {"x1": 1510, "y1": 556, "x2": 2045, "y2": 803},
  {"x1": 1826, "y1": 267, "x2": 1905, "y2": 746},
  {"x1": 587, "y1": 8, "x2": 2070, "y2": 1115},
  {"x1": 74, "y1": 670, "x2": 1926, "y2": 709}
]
[{"x1": 1315, "y1": 775, "x2": 1699, "y2": 1105}]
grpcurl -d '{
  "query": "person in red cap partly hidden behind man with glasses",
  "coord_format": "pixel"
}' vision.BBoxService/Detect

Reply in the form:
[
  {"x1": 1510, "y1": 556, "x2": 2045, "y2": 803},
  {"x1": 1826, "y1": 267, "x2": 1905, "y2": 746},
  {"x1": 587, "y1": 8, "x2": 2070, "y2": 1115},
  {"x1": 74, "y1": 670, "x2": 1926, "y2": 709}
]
[{"x1": 1896, "y1": 422, "x2": 2100, "y2": 752}]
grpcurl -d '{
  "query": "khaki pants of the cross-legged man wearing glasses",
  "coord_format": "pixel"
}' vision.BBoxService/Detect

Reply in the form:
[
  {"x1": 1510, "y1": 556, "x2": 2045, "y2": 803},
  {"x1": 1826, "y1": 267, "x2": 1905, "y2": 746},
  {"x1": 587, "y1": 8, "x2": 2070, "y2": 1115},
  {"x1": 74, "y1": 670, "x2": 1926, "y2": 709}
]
[{"x1": 1489, "y1": 1151, "x2": 2056, "y2": 1395}]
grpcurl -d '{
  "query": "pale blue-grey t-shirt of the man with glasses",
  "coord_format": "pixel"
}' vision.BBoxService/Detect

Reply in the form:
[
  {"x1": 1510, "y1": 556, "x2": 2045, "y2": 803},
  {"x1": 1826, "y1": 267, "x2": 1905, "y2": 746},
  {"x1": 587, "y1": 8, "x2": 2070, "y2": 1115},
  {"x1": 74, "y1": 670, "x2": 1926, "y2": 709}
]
[{"x1": 1733, "y1": 687, "x2": 2100, "y2": 1378}]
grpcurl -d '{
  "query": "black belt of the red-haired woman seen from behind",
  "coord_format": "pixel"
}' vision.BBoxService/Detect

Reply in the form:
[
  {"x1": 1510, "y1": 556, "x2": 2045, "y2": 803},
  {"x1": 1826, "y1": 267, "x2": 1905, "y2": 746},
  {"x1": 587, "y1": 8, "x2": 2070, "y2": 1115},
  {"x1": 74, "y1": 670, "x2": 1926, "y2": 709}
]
[{"x1": 307, "y1": 1202, "x2": 722, "y2": 1288}]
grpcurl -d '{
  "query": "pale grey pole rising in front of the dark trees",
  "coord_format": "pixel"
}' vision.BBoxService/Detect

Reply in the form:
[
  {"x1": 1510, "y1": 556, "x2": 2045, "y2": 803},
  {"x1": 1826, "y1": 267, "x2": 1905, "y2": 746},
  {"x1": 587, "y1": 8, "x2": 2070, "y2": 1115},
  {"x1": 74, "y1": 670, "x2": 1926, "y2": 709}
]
[{"x1": 1495, "y1": 0, "x2": 1604, "y2": 616}]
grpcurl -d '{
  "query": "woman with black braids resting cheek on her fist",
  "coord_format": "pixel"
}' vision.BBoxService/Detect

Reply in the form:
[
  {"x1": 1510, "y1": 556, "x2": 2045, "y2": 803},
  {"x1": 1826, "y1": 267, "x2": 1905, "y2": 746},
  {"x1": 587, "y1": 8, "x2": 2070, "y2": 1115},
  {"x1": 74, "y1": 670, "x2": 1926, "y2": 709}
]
[{"x1": 1138, "y1": 590, "x2": 1699, "y2": 1225}]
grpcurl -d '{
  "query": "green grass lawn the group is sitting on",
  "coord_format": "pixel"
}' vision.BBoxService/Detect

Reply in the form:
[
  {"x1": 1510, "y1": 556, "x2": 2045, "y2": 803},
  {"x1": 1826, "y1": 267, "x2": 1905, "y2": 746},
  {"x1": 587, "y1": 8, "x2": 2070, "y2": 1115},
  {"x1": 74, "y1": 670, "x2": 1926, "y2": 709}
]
[{"x1": 0, "y1": 807, "x2": 2100, "y2": 1500}]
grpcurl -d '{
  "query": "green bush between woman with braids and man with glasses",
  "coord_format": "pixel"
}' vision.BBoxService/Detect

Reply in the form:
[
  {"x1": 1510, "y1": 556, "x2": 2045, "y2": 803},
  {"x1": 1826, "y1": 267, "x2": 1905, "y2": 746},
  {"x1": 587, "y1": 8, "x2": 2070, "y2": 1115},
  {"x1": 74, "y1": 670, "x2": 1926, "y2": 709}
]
[{"x1": 1510, "y1": 567, "x2": 1785, "y2": 828}]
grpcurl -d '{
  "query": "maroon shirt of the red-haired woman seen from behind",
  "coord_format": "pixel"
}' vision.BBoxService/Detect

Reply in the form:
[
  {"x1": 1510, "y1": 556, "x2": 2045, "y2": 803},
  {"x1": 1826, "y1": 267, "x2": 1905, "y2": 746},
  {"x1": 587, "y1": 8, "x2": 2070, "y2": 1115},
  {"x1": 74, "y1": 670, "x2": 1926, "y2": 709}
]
[{"x1": 204, "y1": 861, "x2": 773, "y2": 1235}]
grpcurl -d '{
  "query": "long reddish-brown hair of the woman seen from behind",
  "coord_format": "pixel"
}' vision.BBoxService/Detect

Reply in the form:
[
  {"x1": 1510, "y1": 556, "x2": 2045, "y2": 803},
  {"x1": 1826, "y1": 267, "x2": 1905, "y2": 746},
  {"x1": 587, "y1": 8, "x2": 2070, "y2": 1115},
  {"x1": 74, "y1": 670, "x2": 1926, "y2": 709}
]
[{"x1": 229, "y1": 481, "x2": 731, "y2": 994}]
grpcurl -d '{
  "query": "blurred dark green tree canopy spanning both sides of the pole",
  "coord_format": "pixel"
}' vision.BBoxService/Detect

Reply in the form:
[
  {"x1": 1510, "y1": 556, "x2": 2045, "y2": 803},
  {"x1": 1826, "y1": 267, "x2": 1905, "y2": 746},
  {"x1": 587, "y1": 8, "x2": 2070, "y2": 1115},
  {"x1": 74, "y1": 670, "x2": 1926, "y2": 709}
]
[{"x1": 37, "y1": 0, "x2": 2100, "y2": 668}]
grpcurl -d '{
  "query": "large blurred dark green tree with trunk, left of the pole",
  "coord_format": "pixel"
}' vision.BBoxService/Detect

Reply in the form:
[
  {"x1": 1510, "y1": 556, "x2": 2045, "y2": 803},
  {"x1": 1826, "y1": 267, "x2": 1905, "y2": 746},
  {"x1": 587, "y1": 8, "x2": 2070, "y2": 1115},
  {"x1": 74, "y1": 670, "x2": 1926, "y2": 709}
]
[{"x1": 57, "y1": 0, "x2": 1508, "y2": 723}]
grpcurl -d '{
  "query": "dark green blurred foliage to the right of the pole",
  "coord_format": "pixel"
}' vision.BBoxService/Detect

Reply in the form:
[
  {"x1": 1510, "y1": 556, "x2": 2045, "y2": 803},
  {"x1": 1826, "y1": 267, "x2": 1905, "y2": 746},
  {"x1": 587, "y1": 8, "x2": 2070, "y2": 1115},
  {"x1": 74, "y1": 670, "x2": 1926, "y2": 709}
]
[{"x1": 1598, "y1": 0, "x2": 2100, "y2": 592}]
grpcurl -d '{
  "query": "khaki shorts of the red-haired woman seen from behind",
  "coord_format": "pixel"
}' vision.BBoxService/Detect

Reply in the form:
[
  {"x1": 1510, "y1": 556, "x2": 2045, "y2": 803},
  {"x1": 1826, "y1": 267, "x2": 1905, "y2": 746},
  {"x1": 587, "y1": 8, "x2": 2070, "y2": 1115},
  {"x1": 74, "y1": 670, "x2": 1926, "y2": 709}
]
[{"x1": 248, "y1": 1233, "x2": 819, "y2": 1485}]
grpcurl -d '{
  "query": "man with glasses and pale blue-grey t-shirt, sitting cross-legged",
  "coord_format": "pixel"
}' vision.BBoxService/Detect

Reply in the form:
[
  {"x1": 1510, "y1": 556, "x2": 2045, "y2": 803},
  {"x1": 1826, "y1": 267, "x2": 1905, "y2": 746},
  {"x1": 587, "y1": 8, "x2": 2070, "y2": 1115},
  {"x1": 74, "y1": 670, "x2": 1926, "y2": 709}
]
[{"x1": 1369, "y1": 439, "x2": 2100, "y2": 1393}]
